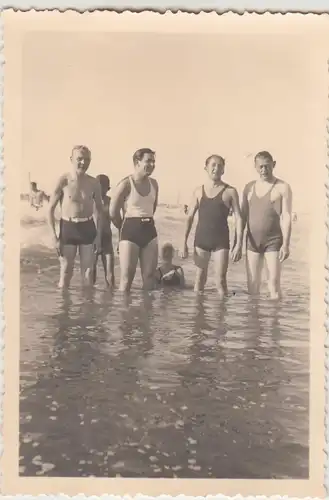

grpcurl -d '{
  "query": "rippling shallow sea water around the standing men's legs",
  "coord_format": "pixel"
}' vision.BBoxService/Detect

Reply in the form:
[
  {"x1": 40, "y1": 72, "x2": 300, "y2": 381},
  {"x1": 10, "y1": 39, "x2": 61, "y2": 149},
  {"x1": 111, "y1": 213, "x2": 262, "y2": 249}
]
[{"x1": 19, "y1": 205, "x2": 309, "y2": 478}]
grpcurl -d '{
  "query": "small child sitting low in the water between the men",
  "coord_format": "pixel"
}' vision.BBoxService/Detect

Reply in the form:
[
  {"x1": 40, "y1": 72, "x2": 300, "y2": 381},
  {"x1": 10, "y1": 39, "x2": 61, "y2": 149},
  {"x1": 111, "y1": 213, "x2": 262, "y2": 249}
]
[{"x1": 156, "y1": 243, "x2": 185, "y2": 288}]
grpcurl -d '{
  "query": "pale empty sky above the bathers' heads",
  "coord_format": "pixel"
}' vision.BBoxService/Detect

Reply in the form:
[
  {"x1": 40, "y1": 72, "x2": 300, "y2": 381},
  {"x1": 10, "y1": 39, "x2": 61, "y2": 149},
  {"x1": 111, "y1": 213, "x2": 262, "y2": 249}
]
[{"x1": 21, "y1": 32, "x2": 315, "y2": 207}]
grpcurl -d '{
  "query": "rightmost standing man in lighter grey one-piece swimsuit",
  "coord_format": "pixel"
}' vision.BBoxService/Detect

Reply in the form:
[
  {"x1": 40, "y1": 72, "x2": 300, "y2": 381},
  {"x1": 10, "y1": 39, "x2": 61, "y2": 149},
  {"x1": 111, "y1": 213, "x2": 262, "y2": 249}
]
[{"x1": 242, "y1": 151, "x2": 292, "y2": 299}]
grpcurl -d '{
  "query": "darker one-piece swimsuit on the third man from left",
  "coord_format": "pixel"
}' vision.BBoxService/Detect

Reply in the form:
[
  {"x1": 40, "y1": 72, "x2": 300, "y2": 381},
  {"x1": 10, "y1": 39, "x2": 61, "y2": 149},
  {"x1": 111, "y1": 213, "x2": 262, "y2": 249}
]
[{"x1": 194, "y1": 184, "x2": 230, "y2": 252}]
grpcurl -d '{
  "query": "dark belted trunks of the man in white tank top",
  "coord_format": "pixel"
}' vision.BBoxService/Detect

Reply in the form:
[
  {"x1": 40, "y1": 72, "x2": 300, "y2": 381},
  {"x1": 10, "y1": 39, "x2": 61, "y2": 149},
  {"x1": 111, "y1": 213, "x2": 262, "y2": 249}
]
[{"x1": 120, "y1": 217, "x2": 157, "y2": 248}]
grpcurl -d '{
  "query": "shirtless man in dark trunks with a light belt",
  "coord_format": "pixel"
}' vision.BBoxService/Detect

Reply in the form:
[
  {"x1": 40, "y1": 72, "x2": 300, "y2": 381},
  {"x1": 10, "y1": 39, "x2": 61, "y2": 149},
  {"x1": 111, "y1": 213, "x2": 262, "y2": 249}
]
[{"x1": 49, "y1": 146, "x2": 103, "y2": 288}]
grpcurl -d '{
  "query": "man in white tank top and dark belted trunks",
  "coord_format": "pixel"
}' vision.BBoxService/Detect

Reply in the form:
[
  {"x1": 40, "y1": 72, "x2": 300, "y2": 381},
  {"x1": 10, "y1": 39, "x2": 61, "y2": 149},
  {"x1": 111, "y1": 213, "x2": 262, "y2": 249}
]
[{"x1": 110, "y1": 148, "x2": 159, "y2": 292}]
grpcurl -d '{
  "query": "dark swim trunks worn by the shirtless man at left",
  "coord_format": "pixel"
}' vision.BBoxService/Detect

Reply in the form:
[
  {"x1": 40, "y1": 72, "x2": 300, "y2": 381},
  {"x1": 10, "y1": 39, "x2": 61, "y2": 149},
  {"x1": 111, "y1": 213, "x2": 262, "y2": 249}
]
[{"x1": 59, "y1": 219, "x2": 97, "y2": 246}]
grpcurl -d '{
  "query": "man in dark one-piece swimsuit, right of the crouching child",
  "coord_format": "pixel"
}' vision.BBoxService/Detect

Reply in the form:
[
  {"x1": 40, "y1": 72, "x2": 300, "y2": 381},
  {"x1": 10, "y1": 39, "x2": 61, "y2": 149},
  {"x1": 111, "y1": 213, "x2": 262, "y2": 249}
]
[{"x1": 182, "y1": 155, "x2": 243, "y2": 297}]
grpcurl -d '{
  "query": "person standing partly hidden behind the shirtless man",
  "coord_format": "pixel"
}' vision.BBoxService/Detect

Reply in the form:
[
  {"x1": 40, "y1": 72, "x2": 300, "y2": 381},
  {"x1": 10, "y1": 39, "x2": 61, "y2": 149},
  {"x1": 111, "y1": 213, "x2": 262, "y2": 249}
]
[{"x1": 93, "y1": 174, "x2": 115, "y2": 288}]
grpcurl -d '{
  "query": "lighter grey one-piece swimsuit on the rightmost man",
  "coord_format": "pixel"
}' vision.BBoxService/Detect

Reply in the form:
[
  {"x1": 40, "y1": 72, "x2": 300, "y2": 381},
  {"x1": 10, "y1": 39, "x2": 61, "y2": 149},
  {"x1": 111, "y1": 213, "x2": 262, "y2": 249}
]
[{"x1": 247, "y1": 181, "x2": 283, "y2": 253}]
